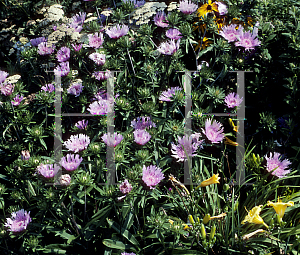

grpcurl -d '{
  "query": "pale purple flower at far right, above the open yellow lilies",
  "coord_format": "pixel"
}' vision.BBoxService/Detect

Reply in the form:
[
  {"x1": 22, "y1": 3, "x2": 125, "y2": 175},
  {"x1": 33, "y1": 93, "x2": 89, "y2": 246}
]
[{"x1": 265, "y1": 152, "x2": 291, "y2": 178}]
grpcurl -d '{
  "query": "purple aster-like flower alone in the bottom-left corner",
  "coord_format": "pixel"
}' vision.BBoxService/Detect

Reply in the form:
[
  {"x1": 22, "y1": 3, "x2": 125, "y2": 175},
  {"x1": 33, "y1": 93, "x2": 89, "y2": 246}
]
[{"x1": 4, "y1": 209, "x2": 31, "y2": 233}]
